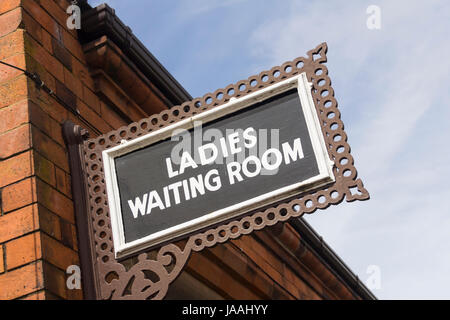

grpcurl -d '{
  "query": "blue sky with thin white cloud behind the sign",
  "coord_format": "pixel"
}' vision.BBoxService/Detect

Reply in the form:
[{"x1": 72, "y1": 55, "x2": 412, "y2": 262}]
[{"x1": 90, "y1": 0, "x2": 450, "y2": 299}]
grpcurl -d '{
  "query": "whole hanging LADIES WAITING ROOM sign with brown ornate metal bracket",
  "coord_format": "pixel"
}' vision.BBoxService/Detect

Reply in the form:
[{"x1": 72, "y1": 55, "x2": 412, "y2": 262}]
[{"x1": 63, "y1": 43, "x2": 370, "y2": 299}]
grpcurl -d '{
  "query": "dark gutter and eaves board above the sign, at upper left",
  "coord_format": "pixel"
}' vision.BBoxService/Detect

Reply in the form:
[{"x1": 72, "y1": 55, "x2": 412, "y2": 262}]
[{"x1": 79, "y1": 1, "x2": 192, "y2": 105}]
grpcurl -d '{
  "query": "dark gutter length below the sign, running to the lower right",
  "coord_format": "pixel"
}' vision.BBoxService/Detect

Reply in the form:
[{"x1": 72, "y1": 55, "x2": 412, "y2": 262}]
[{"x1": 289, "y1": 218, "x2": 377, "y2": 300}]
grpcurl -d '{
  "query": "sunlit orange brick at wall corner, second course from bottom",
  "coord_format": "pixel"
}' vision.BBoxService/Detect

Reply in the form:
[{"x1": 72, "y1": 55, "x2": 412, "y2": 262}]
[{"x1": 5, "y1": 232, "x2": 42, "y2": 270}]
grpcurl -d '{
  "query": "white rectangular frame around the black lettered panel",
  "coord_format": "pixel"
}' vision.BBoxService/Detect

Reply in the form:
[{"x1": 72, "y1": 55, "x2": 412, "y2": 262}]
[{"x1": 102, "y1": 72, "x2": 335, "y2": 259}]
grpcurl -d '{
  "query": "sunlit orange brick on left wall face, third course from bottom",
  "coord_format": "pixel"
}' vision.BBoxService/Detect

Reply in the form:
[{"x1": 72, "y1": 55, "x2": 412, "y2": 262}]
[{"x1": 0, "y1": 204, "x2": 39, "y2": 242}]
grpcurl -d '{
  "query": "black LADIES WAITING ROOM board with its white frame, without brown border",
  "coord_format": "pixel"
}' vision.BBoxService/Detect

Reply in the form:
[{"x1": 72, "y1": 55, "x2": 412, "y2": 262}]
[{"x1": 103, "y1": 73, "x2": 335, "y2": 258}]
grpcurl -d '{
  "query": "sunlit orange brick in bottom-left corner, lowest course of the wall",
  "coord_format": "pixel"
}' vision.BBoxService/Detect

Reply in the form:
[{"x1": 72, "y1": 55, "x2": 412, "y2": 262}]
[{"x1": 0, "y1": 261, "x2": 44, "y2": 300}]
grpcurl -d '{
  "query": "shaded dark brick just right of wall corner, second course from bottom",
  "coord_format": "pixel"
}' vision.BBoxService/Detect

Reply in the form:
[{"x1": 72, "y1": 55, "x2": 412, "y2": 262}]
[{"x1": 41, "y1": 234, "x2": 79, "y2": 270}]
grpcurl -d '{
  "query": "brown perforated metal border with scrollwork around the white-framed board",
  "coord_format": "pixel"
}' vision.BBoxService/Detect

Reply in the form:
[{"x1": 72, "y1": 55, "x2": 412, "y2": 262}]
[{"x1": 75, "y1": 43, "x2": 369, "y2": 299}]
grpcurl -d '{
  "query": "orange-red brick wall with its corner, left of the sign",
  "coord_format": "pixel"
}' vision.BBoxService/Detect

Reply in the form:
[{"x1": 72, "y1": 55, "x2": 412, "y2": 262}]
[{"x1": 0, "y1": 0, "x2": 125, "y2": 299}]
